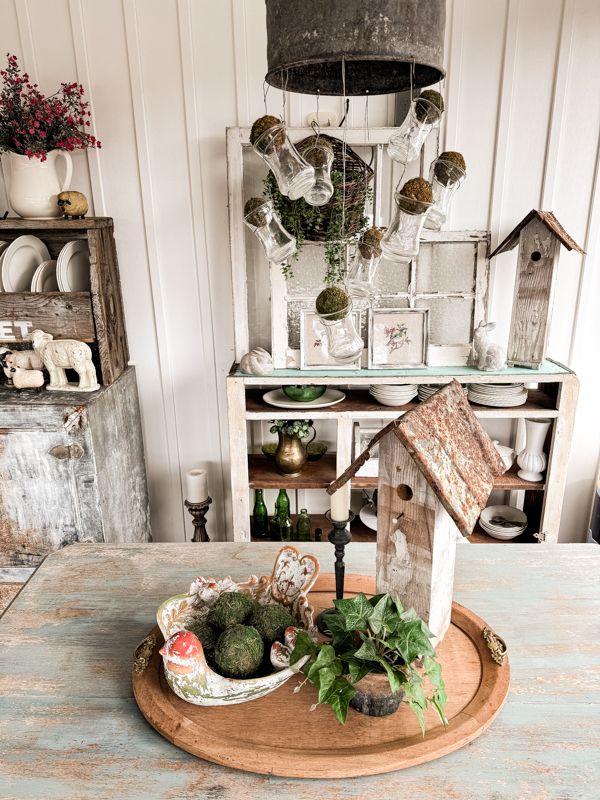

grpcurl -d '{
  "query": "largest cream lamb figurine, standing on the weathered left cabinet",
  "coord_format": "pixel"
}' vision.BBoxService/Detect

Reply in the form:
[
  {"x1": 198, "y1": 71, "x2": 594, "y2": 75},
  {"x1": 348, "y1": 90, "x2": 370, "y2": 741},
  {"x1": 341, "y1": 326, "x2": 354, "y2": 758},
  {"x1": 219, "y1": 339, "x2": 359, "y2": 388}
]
[{"x1": 29, "y1": 330, "x2": 100, "y2": 392}]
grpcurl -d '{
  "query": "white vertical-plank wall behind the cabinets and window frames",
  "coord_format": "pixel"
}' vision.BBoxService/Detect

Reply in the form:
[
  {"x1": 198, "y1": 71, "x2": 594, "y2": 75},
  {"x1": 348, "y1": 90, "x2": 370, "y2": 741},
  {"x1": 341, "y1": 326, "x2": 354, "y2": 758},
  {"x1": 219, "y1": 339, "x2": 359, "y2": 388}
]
[{"x1": 0, "y1": 0, "x2": 600, "y2": 541}]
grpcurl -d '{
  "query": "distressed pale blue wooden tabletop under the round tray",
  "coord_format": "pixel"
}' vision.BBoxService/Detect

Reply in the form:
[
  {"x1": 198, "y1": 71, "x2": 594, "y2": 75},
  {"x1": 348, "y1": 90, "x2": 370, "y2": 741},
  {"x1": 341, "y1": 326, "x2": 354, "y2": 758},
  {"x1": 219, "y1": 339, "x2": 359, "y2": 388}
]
[{"x1": 0, "y1": 542, "x2": 600, "y2": 800}]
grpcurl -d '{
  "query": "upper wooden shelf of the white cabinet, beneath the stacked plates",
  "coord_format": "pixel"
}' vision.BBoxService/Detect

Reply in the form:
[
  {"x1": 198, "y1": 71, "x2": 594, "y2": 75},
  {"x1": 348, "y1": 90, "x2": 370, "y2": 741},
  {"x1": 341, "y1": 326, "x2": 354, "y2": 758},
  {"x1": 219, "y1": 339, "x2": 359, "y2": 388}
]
[{"x1": 245, "y1": 389, "x2": 558, "y2": 420}]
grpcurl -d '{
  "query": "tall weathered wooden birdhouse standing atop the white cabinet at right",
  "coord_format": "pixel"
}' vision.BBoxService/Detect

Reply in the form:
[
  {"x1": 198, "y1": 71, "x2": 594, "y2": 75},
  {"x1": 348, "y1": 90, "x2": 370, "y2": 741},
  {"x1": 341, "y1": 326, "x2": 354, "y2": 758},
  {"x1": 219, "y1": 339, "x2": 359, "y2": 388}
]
[{"x1": 490, "y1": 210, "x2": 584, "y2": 369}]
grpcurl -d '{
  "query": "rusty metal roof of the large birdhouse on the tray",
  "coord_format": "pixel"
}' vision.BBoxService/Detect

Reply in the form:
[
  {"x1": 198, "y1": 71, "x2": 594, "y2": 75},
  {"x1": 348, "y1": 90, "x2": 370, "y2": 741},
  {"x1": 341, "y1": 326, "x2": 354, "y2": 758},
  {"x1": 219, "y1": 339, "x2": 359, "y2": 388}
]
[{"x1": 327, "y1": 380, "x2": 505, "y2": 536}]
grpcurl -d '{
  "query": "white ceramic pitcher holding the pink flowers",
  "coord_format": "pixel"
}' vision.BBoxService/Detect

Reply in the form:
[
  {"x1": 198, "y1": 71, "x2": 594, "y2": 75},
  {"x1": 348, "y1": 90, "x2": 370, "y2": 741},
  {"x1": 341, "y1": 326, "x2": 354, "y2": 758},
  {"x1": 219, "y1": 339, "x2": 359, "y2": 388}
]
[{"x1": 8, "y1": 150, "x2": 73, "y2": 219}]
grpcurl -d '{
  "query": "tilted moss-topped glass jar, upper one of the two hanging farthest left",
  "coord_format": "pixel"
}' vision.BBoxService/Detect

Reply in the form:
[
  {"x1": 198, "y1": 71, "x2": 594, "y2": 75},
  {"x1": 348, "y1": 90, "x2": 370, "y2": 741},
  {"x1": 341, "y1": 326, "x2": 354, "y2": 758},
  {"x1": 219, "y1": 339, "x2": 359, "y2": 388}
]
[{"x1": 251, "y1": 117, "x2": 316, "y2": 200}]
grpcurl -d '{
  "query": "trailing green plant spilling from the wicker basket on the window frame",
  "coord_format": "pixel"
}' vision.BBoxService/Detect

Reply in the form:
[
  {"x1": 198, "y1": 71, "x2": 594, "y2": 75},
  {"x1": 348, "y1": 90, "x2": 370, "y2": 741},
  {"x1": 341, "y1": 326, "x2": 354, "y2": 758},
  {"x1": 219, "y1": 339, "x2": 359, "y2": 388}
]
[{"x1": 263, "y1": 170, "x2": 373, "y2": 283}]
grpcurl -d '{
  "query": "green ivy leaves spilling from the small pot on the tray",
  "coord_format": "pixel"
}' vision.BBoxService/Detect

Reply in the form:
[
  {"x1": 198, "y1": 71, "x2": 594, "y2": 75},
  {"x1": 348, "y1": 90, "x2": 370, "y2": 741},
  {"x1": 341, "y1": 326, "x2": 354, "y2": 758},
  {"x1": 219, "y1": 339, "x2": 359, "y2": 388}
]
[{"x1": 290, "y1": 592, "x2": 446, "y2": 735}]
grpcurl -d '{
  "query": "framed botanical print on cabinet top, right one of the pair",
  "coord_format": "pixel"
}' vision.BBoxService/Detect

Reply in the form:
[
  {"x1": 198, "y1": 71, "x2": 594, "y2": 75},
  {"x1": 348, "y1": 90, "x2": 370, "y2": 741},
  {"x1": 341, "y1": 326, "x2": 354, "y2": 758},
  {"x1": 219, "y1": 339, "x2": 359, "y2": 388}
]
[{"x1": 369, "y1": 308, "x2": 429, "y2": 369}]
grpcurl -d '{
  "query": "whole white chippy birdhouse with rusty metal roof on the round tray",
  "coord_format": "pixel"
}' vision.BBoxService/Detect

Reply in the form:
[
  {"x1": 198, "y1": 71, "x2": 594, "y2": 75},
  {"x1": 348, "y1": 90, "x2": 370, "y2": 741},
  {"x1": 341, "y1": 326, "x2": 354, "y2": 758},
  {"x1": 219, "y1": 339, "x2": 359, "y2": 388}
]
[{"x1": 327, "y1": 381, "x2": 505, "y2": 642}]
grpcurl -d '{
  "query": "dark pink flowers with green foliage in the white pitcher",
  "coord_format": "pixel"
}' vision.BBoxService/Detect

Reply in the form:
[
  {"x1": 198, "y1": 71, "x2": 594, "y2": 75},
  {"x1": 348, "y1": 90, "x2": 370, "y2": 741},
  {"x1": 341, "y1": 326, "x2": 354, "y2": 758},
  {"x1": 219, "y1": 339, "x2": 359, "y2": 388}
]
[{"x1": 0, "y1": 54, "x2": 101, "y2": 161}]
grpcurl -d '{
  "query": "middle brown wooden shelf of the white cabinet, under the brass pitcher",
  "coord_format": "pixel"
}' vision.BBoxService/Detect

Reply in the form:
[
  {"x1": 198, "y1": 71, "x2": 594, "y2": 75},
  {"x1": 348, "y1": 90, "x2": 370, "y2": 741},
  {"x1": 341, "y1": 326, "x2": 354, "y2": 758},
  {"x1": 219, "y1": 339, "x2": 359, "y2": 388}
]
[{"x1": 248, "y1": 453, "x2": 545, "y2": 491}]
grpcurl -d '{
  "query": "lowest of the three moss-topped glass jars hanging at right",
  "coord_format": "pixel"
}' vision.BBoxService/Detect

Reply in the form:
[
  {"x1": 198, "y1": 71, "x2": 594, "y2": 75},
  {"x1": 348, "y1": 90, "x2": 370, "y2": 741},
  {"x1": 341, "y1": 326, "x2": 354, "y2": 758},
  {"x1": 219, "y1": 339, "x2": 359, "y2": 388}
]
[{"x1": 381, "y1": 178, "x2": 433, "y2": 261}]
